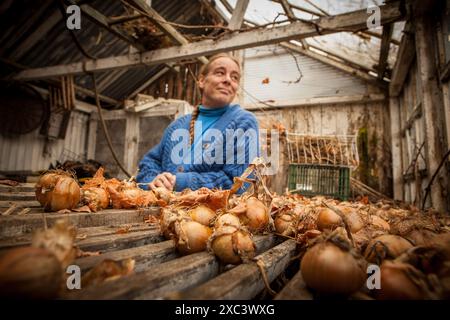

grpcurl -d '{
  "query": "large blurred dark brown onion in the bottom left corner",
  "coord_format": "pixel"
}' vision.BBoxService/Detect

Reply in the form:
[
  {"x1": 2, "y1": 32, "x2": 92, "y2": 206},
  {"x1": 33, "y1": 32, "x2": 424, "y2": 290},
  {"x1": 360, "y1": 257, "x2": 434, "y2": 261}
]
[{"x1": 0, "y1": 247, "x2": 63, "y2": 299}]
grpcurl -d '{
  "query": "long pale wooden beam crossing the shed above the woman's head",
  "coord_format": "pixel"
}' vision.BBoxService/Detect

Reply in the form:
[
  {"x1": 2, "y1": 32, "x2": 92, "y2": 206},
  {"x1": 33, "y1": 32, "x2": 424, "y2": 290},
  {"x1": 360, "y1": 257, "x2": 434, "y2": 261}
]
[{"x1": 14, "y1": 3, "x2": 403, "y2": 80}]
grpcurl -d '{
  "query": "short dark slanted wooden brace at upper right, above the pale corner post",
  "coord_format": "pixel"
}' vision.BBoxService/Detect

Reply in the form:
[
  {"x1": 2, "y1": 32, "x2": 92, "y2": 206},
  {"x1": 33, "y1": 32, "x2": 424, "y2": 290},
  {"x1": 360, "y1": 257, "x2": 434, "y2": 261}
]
[{"x1": 389, "y1": 23, "x2": 416, "y2": 97}]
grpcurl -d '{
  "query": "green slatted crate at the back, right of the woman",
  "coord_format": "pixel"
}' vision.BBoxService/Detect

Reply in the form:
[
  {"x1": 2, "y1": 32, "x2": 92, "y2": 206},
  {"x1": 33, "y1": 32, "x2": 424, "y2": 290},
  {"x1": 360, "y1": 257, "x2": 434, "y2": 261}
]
[{"x1": 288, "y1": 164, "x2": 350, "y2": 200}]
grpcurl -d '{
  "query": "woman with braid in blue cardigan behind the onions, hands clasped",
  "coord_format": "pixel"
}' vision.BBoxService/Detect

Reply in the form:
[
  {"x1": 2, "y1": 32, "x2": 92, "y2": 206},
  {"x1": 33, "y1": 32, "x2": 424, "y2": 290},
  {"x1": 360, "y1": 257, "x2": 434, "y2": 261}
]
[{"x1": 137, "y1": 53, "x2": 259, "y2": 192}]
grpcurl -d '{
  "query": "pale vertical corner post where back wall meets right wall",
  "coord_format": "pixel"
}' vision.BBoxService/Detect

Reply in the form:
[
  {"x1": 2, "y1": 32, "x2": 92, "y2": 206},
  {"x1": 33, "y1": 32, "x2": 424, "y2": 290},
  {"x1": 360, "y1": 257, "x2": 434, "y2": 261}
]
[{"x1": 389, "y1": 98, "x2": 404, "y2": 200}]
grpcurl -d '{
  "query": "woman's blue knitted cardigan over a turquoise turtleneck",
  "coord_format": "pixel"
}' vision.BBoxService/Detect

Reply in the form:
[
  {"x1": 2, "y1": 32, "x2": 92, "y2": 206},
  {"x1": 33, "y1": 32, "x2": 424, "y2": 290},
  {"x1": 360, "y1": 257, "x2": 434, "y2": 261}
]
[{"x1": 136, "y1": 104, "x2": 259, "y2": 193}]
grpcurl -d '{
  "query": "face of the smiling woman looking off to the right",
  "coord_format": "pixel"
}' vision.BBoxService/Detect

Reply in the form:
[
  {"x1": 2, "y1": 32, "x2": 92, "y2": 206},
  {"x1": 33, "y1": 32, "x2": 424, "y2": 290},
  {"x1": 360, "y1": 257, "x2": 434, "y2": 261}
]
[{"x1": 198, "y1": 57, "x2": 241, "y2": 108}]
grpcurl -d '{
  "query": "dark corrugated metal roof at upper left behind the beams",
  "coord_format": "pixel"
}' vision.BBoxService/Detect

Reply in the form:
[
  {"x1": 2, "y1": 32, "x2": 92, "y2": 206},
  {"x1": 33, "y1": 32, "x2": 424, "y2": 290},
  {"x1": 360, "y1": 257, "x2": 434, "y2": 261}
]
[{"x1": 0, "y1": 0, "x2": 218, "y2": 105}]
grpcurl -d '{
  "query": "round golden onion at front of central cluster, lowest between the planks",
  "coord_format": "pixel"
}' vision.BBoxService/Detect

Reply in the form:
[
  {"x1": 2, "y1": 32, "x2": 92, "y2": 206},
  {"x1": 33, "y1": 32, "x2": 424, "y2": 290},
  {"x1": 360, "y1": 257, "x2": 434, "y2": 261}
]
[{"x1": 210, "y1": 226, "x2": 256, "y2": 264}]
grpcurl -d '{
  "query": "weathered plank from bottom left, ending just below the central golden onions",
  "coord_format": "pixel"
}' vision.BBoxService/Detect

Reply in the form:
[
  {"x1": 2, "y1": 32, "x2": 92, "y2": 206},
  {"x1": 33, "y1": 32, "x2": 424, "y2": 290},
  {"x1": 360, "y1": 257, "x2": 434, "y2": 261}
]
[{"x1": 66, "y1": 235, "x2": 275, "y2": 299}]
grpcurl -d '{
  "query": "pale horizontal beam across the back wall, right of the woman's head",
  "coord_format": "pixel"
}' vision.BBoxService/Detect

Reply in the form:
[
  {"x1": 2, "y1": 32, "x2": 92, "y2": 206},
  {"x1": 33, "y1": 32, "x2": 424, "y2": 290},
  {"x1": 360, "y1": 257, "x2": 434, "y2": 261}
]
[{"x1": 244, "y1": 93, "x2": 386, "y2": 110}]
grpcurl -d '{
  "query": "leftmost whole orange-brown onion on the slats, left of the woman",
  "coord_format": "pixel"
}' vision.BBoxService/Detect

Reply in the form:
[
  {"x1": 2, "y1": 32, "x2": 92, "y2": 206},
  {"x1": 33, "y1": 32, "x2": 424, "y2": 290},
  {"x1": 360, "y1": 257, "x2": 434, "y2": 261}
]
[{"x1": 35, "y1": 171, "x2": 80, "y2": 211}]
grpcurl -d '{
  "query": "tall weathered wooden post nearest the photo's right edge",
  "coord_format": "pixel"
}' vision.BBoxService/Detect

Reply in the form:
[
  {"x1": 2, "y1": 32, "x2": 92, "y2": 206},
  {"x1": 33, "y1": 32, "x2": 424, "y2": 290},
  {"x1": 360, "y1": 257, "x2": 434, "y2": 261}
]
[{"x1": 415, "y1": 15, "x2": 448, "y2": 211}]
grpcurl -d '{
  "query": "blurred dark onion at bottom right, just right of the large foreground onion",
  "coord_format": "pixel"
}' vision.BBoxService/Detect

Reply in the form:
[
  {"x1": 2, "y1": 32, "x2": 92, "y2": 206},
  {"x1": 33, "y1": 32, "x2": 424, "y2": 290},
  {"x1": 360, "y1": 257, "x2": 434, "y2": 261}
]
[{"x1": 374, "y1": 260, "x2": 424, "y2": 300}]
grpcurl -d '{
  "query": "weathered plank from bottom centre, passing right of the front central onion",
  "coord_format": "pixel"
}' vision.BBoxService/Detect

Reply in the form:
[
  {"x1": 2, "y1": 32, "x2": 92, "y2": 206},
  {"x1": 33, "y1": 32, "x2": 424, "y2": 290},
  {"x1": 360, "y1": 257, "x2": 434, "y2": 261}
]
[{"x1": 163, "y1": 240, "x2": 296, "y2": 300}]
